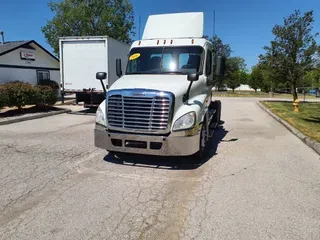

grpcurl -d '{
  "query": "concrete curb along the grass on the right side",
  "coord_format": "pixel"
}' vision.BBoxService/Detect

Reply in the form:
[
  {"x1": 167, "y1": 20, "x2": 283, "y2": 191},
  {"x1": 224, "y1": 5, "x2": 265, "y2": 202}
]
[{"x1": 257, "y1": 102, "x2": 320, "y2": 155}]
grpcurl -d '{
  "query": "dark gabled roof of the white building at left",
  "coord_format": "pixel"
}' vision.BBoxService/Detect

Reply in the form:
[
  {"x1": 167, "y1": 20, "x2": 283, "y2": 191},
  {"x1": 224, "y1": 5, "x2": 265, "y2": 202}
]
[{"x1": 0, "y1": 40, "x2": 59, "y2": 61}]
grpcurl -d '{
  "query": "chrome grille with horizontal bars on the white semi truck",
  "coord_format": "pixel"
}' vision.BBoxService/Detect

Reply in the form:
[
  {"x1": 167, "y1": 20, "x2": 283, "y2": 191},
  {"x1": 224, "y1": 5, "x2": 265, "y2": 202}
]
[{"x1": 107, "y1": 90, "x2": 173, "y2": 133}]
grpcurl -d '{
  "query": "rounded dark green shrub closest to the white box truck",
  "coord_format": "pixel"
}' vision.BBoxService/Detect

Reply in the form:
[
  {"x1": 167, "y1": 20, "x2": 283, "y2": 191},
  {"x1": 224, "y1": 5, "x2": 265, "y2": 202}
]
[{"x1": 34, "y1": 85, "x2": 58, "y2": 107}]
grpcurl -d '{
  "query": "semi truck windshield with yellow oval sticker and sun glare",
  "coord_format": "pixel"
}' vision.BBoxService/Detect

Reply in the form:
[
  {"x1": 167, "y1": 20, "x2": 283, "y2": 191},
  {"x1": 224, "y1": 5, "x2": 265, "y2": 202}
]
[{"x1": 126, "y1": 46, "x2": 203, "y2": 74}]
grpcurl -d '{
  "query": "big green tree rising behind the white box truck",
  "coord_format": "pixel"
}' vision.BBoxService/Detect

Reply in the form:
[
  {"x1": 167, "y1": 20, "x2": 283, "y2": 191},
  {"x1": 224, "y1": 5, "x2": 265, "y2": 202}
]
[{"x1": 41, "y1": 0, "x2": 134, "y2": 56}]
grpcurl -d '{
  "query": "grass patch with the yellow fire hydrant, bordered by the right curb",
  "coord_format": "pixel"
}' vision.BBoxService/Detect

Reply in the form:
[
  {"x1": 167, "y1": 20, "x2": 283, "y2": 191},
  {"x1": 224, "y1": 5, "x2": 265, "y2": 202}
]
[{"x1": 261, "y1": 102, "x2": 320, "y2": 142}]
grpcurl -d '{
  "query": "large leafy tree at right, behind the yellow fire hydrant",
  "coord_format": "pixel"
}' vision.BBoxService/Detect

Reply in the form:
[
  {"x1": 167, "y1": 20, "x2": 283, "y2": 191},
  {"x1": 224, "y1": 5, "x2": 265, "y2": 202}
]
[{"x1": 251, "y1": 10, "x2": 320, "y2": 100}]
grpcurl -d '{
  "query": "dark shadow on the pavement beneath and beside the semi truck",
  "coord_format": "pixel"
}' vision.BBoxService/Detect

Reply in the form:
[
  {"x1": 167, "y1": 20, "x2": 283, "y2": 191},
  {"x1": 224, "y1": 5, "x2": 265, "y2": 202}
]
[{"x1": 104, "y1": 123, "x2": 231, "y2": 170}]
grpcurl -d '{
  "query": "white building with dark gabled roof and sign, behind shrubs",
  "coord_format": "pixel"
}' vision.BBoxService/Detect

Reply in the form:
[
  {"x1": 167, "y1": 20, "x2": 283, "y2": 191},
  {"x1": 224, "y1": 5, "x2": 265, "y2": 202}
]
[{"x1": 0, "y1": 40, "x2": 60, "y2": 86}]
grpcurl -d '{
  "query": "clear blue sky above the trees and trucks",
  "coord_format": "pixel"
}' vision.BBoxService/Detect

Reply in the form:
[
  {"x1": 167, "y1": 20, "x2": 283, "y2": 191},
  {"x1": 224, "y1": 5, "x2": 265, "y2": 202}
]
[{"x1": 0, "y1": 0, "x2": 320, "y2": 68}]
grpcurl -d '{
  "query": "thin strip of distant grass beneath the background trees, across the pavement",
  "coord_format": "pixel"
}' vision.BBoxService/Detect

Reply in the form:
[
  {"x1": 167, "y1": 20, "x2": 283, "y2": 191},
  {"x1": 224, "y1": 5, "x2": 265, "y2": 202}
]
[{"x1": 212, "y1": 91, "x2": 315, "y2": 100}]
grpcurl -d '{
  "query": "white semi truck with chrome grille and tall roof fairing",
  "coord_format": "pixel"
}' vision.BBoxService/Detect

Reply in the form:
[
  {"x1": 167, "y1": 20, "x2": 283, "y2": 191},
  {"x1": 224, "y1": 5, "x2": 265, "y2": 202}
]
[{"x1": 94, "y1": 12, "x2": 225, "y2": 158}]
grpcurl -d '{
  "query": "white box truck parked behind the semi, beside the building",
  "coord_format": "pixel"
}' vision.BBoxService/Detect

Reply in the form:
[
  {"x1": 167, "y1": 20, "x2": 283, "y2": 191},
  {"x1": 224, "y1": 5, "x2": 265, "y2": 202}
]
[{"x1": 59, "y1": 36, "x2": 130, "y2": 108}]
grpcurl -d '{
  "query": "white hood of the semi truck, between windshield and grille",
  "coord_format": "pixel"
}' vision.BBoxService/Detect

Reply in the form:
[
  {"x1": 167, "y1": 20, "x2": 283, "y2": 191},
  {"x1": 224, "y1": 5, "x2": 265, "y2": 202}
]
[{"x1": 109, "y1": 74, "x2": 190, "y2": 96}]
